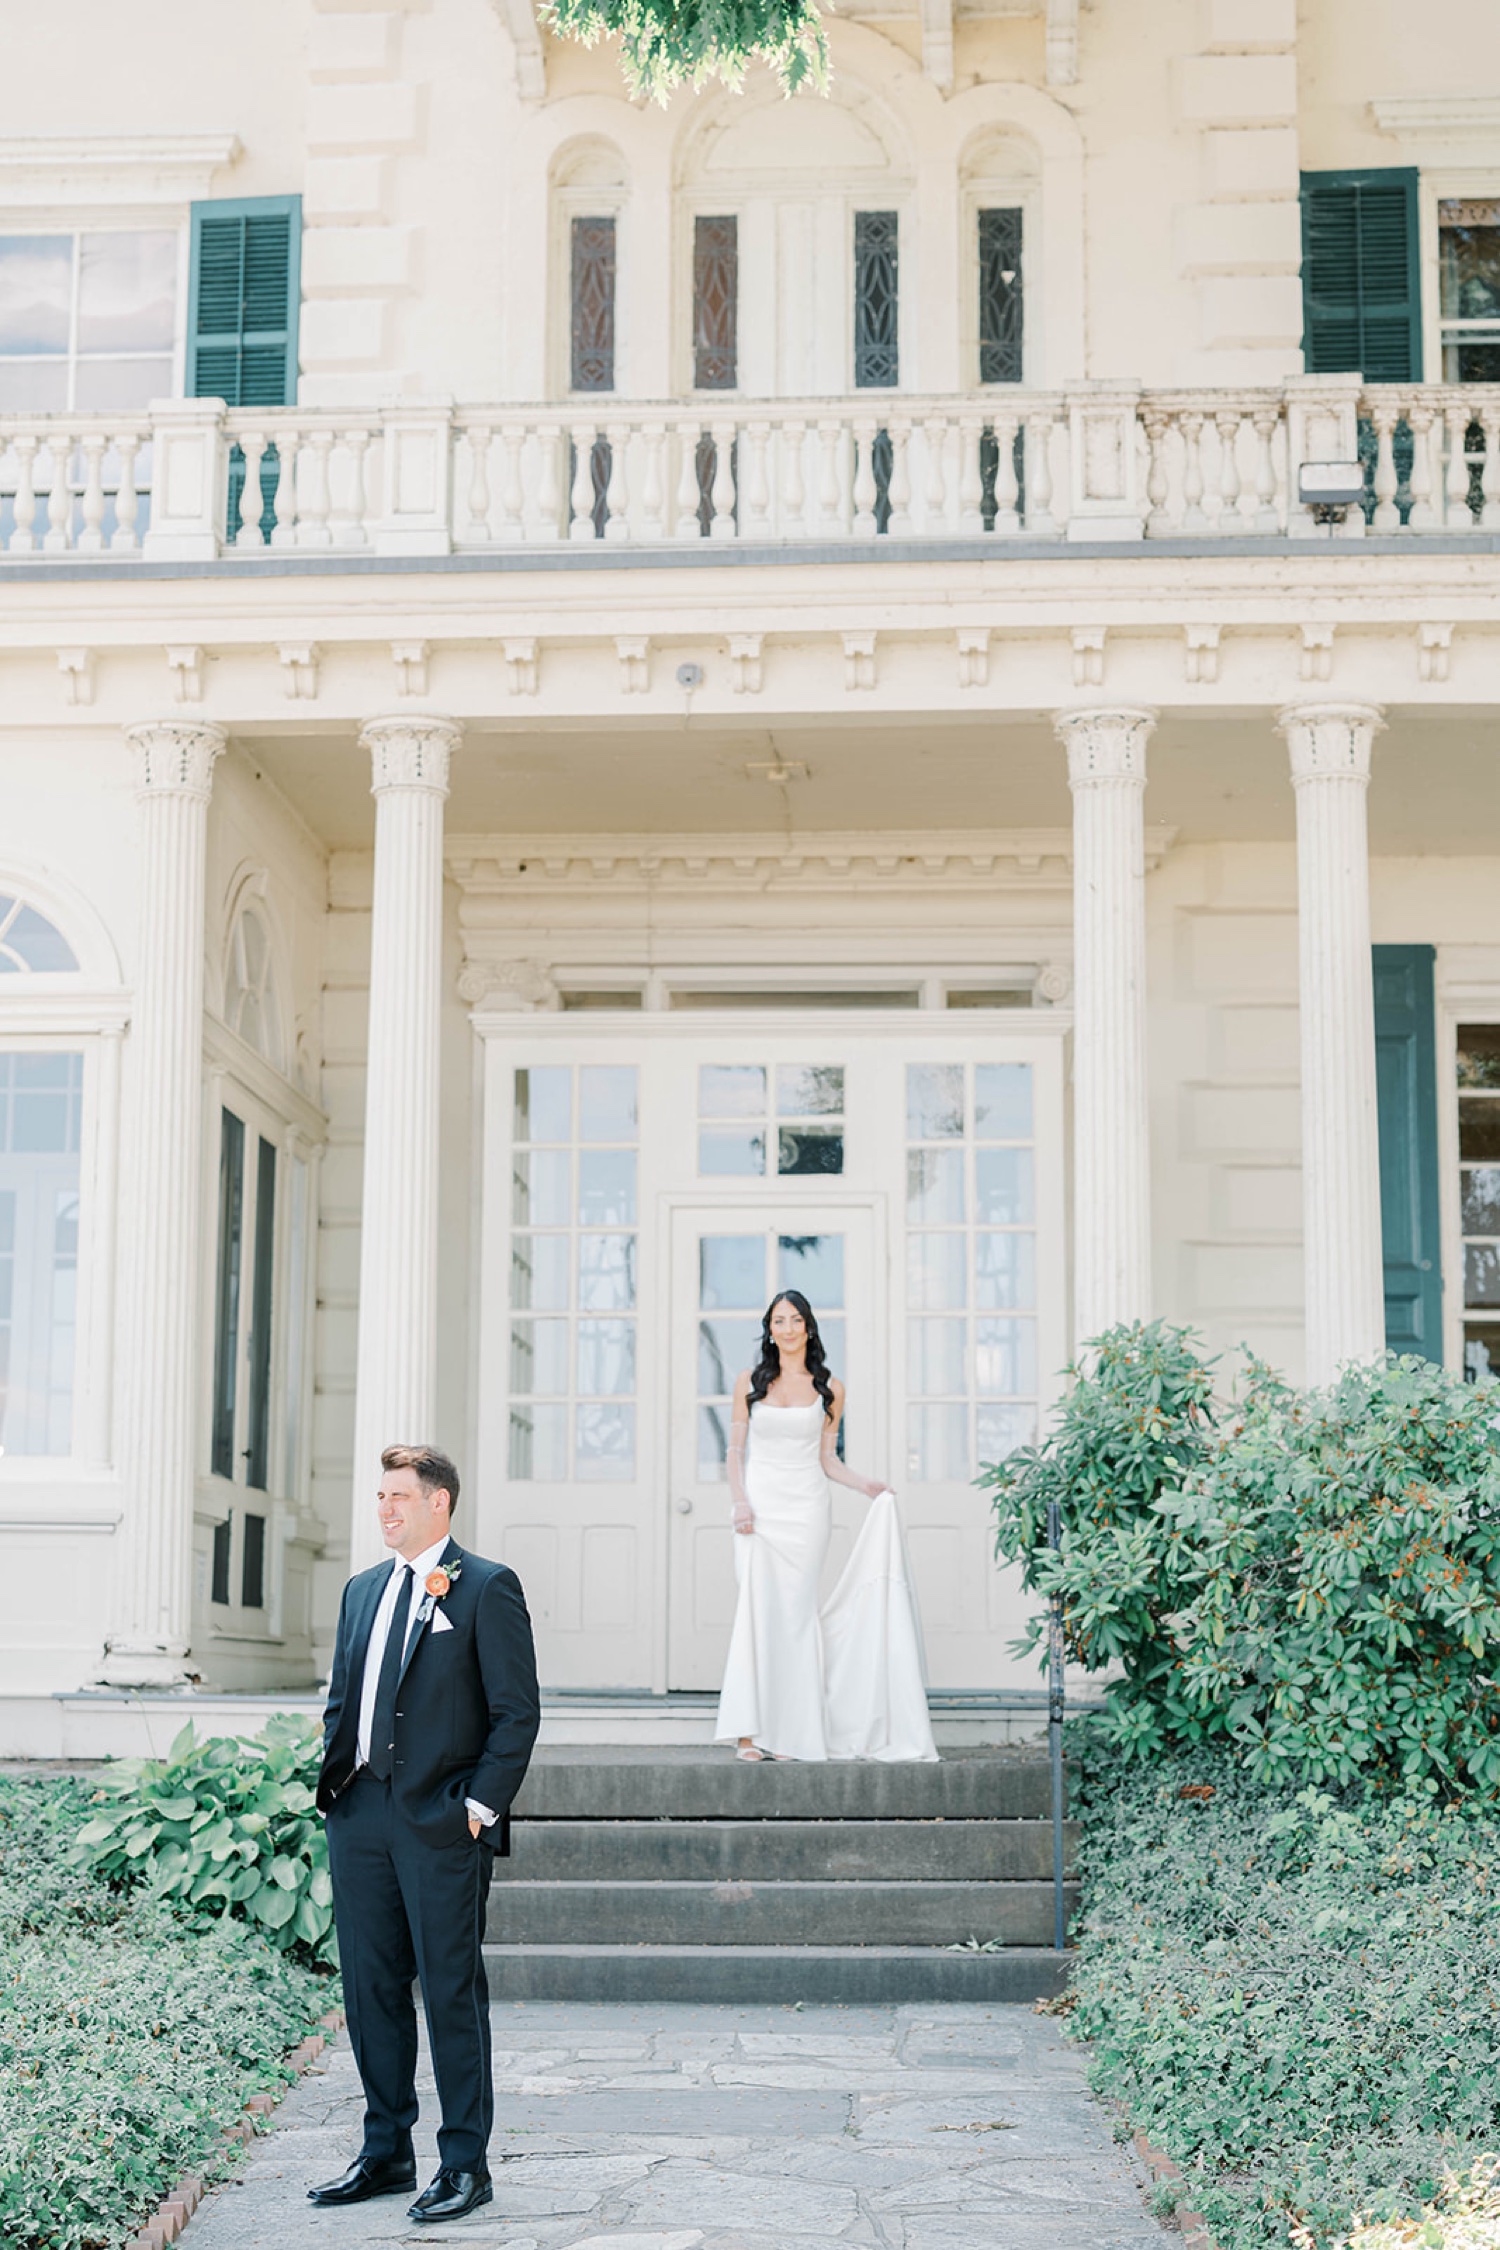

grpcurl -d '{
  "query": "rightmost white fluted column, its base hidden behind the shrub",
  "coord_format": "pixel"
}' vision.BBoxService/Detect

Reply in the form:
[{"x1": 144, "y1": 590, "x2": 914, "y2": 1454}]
[{"x1": 1277, "y1": 704, "x2": 1385, "y2": 1384}]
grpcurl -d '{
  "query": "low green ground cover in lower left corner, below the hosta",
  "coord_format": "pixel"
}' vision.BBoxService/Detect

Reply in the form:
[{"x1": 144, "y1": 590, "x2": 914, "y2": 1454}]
[{"x1": 0, "y1": 1775, "x2": 335, "y2": 2250}]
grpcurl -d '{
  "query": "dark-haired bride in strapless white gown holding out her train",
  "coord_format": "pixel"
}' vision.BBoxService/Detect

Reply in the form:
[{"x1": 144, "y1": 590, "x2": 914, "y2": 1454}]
[{"x1": 715, "y1": 1289, "x2": 938, "y2": 1762}]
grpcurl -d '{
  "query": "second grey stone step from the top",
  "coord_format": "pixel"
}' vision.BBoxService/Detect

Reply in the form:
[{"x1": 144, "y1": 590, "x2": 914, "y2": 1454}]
[{"x1": 495, "y1": 1820, "x2": 1077, "y2": 1883}]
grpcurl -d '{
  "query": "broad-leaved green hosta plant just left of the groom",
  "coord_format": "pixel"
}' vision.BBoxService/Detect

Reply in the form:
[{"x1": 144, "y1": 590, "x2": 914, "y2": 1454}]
[{"x1": 76, "y1": 1712, "x2": 337, "y2": 1967}]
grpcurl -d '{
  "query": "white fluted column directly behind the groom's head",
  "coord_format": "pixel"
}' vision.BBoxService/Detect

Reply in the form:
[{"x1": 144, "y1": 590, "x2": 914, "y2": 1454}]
[{"x1": 351, "y1": 718, "x2": 461, "y2": 1571}]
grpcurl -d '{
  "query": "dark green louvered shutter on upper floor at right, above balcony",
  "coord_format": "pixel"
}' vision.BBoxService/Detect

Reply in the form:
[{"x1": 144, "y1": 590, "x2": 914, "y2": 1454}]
[{"x1": 1302, "y1": 167, "x2": 1421, "y2": 383}]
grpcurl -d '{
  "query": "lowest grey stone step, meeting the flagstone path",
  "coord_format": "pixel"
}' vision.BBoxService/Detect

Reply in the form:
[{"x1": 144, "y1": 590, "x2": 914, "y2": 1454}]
[{"x1": 484, "y1": 1944, "x2": 1070, "y2": 2007}]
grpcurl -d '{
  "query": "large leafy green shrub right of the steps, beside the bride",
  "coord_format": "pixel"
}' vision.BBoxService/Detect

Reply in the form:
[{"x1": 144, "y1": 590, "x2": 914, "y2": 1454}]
[{"x1": 983, "y1": 1325, "x2": 1500, "y2": 1791}]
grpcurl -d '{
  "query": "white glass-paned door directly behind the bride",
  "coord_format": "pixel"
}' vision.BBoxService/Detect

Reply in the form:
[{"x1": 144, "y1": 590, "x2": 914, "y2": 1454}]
[{"x1": 668, "y1": 1197, "x2": 886, "y2": 1688}]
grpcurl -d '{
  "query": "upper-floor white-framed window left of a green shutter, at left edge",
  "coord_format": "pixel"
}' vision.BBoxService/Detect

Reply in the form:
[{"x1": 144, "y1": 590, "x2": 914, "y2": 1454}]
[{"x1": 0, "y1": 227, "x2": 187, "y2": 414}]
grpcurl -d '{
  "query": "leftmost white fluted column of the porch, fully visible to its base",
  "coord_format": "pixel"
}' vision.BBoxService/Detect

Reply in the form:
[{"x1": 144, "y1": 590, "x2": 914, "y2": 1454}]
[{"x1": 101, "y1": 720, "x2": 225, "y2": 1688}]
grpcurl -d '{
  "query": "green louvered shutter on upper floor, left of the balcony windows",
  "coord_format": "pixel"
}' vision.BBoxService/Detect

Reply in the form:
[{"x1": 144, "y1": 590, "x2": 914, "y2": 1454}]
[{"x1": 187, "y1": 196, "x2": 301, "y2": 407}]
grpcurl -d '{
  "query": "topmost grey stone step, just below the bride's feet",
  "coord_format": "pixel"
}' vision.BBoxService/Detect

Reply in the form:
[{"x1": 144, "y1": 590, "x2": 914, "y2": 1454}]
[{"x1": 513, "y1": 1746, "x2": 1052, "y2": 1820}]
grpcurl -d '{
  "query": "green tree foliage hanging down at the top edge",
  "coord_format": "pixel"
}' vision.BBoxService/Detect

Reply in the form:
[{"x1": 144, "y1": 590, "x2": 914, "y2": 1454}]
[{"x1": 540, "y1": 0, "x2": 828, "y2": 101}]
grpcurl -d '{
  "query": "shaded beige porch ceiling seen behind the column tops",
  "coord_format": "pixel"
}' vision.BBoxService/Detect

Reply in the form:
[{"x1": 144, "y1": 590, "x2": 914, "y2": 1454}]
[{"x1": 236, "y1": 698, "x2": 1500, "y2": 855}]
